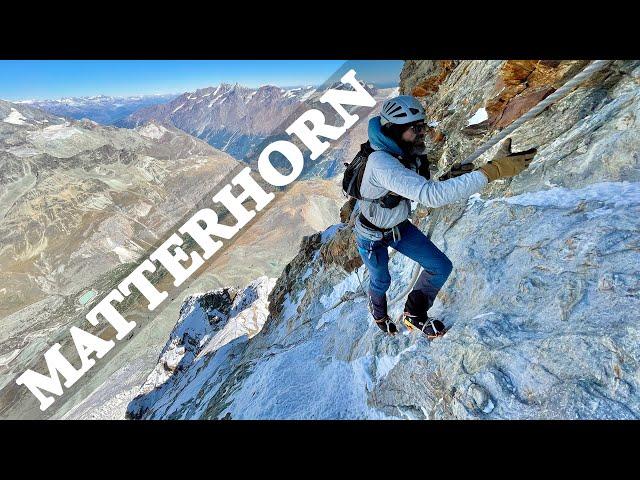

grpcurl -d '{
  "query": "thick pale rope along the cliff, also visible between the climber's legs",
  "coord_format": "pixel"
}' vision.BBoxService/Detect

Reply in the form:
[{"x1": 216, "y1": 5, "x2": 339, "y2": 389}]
[{"x1": 388, "y1": 60, "x2": 611, "y2": 306}]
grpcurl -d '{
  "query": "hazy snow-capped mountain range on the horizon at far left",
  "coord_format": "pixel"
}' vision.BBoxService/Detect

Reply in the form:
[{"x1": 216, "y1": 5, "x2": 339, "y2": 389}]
[{"x1": 16, "y1": 93, "x2": 178, "y2": 125}]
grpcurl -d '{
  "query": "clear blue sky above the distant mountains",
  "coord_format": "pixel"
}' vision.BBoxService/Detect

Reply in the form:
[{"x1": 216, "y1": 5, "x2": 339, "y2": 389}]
[{"x1": 0, "y1": 60, "x2": 402, "y2": 101}]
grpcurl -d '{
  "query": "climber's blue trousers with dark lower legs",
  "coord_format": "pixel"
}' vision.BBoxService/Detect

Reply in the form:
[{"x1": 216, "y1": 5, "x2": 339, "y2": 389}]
[{"x1": 356, "y1": 220, "x2": 453, "y2": 320}]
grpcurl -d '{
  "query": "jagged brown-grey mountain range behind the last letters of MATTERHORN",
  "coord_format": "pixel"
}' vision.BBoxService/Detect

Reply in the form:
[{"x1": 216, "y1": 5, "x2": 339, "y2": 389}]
[{"x1": 118, "y1": 83, "x2": 397, "y2": 178}]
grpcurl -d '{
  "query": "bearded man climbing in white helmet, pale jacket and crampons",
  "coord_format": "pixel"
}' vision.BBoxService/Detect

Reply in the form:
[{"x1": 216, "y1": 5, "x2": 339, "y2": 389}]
[{"x1": 353, "y1": 95, "x2": 536, "y2": 338}]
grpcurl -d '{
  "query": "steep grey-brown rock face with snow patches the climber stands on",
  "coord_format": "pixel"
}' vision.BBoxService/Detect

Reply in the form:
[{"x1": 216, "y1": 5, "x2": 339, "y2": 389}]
[{"x1": 130, "y1": 61, "x2": 640, "y2": 419}]
